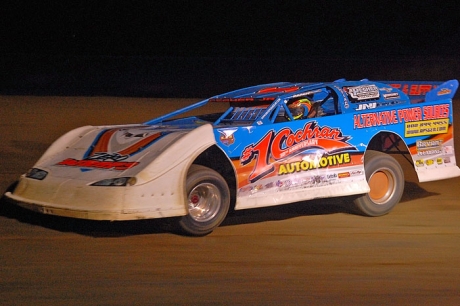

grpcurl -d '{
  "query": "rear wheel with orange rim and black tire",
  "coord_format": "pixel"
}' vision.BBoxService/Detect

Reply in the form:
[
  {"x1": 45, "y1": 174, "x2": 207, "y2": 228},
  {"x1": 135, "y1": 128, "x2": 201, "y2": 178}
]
[{"x1": 354, "y1": 150, "x2": 404, "y2": 217}]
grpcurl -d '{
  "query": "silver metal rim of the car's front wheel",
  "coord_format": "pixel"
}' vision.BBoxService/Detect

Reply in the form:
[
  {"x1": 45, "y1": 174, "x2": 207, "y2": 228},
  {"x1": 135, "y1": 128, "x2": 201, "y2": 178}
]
[{"x1": 188, "y1": 183, "x2": 222, "y2": 222}]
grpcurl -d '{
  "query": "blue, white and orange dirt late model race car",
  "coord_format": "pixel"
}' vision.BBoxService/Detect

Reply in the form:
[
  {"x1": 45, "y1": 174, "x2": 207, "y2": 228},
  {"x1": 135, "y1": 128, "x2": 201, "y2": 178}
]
[{"x1": 5, "y1": 80, "x2": 460, "y2": 236}]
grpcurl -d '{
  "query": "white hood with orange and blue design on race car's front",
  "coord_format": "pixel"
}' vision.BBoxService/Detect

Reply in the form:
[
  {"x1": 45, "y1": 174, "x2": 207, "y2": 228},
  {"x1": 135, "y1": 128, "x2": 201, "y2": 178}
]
[{"x1": 34, "y1": 125, "x2": 205, "y2": 182}]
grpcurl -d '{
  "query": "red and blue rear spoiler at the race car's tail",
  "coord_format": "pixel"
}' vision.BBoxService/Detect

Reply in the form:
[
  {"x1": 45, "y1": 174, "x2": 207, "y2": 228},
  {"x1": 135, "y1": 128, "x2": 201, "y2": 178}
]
[{"x1": 380, "y1": 79, "x2": 458, "y2": 102}]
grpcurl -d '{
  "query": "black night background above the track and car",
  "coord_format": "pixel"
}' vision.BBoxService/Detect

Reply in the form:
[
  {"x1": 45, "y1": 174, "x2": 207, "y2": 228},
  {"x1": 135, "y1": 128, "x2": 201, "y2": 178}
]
[{"x1": 0, "y1": 0, "x2": 460, "y2": 97}]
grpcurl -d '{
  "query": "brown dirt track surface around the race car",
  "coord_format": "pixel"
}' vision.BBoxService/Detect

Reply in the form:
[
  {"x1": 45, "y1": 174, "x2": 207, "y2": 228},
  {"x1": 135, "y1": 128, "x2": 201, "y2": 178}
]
[{"x1": 0, "y1": 97, "x2": 460, "y2": 305}]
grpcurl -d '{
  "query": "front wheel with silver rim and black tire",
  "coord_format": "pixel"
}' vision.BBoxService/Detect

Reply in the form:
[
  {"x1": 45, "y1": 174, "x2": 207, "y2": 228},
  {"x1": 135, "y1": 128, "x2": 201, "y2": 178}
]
[{"x1": 179, "y1": 165, "x2": 230, "y2": 236}]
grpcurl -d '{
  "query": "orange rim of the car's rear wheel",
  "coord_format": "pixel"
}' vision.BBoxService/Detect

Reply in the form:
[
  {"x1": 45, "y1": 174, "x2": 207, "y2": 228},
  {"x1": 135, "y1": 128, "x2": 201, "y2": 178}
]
[{"x1": 369, "y1": 169, "x2": 396, "y2": 204}]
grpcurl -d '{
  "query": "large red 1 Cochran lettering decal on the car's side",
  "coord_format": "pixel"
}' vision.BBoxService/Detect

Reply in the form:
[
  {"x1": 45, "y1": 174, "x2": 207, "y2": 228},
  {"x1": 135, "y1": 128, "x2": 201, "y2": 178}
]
[{"x1": 240, "y1": 121, "x2": 356, "y2": 183}]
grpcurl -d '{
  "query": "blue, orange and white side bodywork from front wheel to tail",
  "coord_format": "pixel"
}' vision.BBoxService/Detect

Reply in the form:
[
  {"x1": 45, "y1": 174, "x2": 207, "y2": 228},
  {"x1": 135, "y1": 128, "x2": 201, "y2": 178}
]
[{"x1": 215, "y1": 82, "x2": 460, "y2": 209}]
